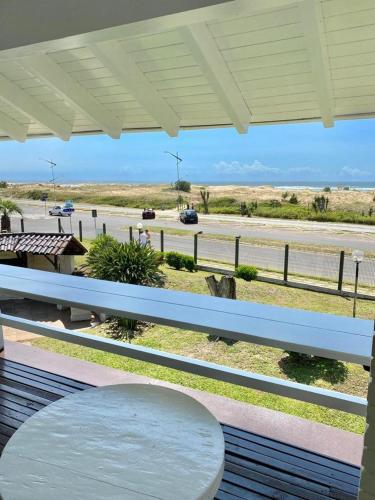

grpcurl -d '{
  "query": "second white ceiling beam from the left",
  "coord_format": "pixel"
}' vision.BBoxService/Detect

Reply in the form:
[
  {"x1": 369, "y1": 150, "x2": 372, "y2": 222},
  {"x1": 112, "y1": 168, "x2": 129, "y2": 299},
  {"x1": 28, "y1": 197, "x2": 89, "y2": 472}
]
[{"x1": 0, "y1": 75, "x2": 72, "y2": 141}]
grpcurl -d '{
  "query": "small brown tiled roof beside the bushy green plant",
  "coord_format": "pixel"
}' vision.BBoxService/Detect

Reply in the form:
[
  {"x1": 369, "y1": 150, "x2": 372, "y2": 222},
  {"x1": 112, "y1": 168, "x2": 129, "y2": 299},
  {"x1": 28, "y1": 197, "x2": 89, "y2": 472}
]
[{"x1": 0, "y1": 233, "x2": 87, "y2": 255}]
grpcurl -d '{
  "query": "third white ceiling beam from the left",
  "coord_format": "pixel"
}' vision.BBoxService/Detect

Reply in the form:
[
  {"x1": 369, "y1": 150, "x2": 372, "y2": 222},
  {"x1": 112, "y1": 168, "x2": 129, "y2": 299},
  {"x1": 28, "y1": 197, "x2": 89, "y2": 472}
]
[{"x1": 20, "y1": 55, "x2": 122, "y2": 139}]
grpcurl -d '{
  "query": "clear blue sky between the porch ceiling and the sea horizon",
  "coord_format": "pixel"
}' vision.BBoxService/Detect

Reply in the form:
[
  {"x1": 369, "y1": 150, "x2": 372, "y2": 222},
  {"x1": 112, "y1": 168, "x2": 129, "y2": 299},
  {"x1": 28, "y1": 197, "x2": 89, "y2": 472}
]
[{"x1": 0, "y1": 120, "x2": 375, "y2": 184}]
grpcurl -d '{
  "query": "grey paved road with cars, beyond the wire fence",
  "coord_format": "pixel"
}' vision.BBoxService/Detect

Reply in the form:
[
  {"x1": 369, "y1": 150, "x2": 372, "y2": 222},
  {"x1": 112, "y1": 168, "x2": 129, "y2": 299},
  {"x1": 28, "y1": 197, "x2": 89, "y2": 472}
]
[{"x1": 13, "y1": 203, "x2": 375, "y2": 286}]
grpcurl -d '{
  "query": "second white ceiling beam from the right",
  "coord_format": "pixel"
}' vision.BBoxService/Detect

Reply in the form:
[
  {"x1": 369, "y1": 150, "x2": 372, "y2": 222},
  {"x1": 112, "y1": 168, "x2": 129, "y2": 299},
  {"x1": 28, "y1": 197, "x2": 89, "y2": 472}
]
[{"x1": 179, "y1": 23, "x2": 251, "y2": 134}]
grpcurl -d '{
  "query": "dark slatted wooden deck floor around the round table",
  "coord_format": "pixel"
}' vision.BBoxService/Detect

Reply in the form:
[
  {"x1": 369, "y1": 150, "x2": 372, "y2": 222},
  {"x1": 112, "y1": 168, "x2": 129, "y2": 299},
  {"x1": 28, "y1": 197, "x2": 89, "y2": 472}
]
[{"x1": 0, "y1": 359, "x2": 359, "y2": 500}]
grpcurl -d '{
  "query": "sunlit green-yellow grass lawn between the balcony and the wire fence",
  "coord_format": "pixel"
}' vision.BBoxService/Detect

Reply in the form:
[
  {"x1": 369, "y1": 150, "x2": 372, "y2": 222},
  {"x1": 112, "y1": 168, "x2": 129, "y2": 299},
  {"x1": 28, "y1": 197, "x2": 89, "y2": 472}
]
[{"x1": 32, "y1": 266, "x2": 375, "y2": 433}]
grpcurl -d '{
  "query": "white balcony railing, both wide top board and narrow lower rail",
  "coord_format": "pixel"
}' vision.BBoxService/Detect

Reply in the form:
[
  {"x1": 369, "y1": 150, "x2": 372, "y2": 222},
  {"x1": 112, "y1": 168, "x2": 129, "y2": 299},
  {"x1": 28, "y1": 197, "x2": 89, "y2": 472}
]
[{"x1": 0, "y1": 265, "x2": 373, "y2": 415}]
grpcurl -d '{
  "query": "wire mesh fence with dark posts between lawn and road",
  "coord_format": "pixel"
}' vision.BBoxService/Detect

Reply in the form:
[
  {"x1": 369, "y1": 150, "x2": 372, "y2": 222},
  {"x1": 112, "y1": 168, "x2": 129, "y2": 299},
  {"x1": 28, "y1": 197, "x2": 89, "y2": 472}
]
[{"x1": 15, "y1": 218, "x2": 375, "y2": 299}]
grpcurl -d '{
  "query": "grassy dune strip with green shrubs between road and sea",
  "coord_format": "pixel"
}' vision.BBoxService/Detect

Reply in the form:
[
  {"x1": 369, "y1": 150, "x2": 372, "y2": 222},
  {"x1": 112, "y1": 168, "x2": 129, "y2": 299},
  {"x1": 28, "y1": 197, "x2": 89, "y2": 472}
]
[{"x1": 6, "y1": 180, "x2": 375, "y2": 225}]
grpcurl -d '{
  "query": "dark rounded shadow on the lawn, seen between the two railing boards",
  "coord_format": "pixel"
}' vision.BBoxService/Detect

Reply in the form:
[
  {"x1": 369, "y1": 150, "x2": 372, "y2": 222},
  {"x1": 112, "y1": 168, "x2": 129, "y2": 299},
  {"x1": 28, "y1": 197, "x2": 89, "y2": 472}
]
[{"x1": 279, "y1": 353, "x2": 348, "y2": 385}]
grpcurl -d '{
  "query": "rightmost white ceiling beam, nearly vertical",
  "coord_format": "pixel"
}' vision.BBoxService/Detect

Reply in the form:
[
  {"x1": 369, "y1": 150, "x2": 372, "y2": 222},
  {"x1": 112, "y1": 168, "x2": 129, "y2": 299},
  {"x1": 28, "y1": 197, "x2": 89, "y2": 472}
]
[{"x1": 299, "y1": 0, "x2": 334, "y2": 127}]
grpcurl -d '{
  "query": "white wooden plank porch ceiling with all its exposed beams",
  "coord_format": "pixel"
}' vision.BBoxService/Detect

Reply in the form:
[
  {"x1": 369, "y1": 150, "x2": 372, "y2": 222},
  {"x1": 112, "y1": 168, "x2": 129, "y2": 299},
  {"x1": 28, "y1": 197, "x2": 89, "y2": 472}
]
[{"x1": 0, "y1": 0, "x2": 375, "y2": 141}]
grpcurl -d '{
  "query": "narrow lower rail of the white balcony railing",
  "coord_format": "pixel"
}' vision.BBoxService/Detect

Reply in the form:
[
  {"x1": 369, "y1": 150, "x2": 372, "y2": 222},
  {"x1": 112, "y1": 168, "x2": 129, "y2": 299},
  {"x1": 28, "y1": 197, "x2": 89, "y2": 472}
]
[{"x1": 0, "y1": 312, "x2": 367, "y2": 416}]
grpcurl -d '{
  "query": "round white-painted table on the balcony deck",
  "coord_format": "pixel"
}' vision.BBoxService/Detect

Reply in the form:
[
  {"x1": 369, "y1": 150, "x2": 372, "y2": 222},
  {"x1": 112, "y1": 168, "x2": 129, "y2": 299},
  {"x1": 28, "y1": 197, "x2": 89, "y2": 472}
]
[{"x1": 0, "y1": 384, "x2": 224, "y2": 500}]
